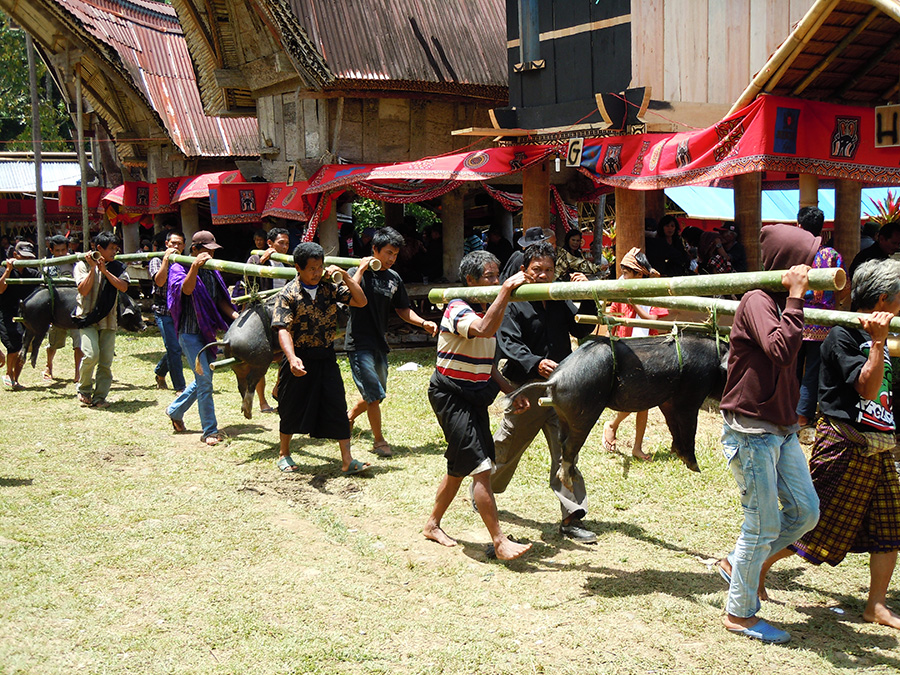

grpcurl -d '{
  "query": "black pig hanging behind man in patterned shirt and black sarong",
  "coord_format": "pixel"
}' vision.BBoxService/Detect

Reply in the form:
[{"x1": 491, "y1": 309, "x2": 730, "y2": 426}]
[{"x1": 195, "y1": 296, "x2": 280, "y2": 419}]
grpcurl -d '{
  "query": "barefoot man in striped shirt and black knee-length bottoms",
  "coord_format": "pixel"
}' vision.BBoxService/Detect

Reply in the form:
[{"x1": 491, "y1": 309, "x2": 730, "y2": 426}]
[{"x1": 422, "y1": 251, "x2": 531, "y2": 560}]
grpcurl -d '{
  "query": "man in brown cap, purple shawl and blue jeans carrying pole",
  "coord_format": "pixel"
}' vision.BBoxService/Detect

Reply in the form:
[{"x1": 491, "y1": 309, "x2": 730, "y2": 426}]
[{"x1": 166, "y1": 230, "x2": 238, "y2": 446}]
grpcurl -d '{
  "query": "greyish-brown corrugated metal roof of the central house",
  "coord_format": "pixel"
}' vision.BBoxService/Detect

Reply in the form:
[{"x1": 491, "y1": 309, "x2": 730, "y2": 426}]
[{"x1": 290, "y1": 0, "x2": 507, "y2": 96}]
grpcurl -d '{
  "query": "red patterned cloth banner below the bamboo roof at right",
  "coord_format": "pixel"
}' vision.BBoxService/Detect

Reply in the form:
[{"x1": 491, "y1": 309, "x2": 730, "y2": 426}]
[{"x1": 581, "y1": 96, "x2": 900, "y2": 190}]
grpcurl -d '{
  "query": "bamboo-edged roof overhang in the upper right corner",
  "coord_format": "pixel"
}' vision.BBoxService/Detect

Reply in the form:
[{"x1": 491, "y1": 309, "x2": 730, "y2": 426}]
[{"x1": 731, "y1": 0, "x2": 900, "y2": 112}]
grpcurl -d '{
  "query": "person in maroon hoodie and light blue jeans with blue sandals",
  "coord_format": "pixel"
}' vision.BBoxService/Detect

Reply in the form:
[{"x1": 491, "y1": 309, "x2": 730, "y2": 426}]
[{"x1": 718, "y1": 225, "x2": 821, "y2": 643}]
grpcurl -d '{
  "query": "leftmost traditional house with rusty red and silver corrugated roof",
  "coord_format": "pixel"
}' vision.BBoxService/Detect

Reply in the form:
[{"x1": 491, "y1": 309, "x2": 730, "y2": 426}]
[{"x1": 0, "y1": 0, "x2": 259, "y2": 250}]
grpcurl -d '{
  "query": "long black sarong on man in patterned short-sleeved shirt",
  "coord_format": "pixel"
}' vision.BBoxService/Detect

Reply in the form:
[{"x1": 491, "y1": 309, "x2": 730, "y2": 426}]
[{"x1": 278, "y1": 347, "x2": 350, "y2": 440}]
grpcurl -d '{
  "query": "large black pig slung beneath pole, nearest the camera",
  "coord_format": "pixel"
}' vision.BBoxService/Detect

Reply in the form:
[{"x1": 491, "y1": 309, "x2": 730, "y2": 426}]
[{"x1": 510, "y1": 333, "x2": 728, "y2": 486}]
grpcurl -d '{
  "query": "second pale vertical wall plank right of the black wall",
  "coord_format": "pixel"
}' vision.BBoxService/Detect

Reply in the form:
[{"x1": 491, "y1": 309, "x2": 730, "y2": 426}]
[{"x1": 663, "y1": 0, "x2": 718, "y2": 101}]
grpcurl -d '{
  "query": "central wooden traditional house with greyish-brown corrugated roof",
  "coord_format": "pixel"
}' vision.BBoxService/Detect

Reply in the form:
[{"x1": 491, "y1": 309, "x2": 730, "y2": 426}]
[{"x1": 172, "y1": 0, "x2": 507, "y2": 276}]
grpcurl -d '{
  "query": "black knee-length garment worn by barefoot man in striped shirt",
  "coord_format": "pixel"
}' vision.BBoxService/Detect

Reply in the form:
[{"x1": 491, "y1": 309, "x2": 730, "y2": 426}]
[{"x1": 428, "y1": 371, "x2": 500, "y2": 478}]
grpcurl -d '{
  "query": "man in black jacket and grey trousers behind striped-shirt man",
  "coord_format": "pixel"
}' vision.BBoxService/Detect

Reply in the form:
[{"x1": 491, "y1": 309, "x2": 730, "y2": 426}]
[{"x1": 488, "y1": 241, "x2": 597, "y2": 544}]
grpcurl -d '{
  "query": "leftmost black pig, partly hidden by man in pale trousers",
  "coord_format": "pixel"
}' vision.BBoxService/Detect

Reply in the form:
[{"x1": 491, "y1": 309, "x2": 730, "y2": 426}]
[{"x1": 19, "y1": 288, "x2": 147, "y2": 368}]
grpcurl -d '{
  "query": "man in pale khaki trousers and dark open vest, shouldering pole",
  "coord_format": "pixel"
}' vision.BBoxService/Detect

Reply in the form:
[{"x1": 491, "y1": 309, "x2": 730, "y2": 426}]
[{"x1": 72, "y1": 232, "x2": 128, "y2": 408}]
